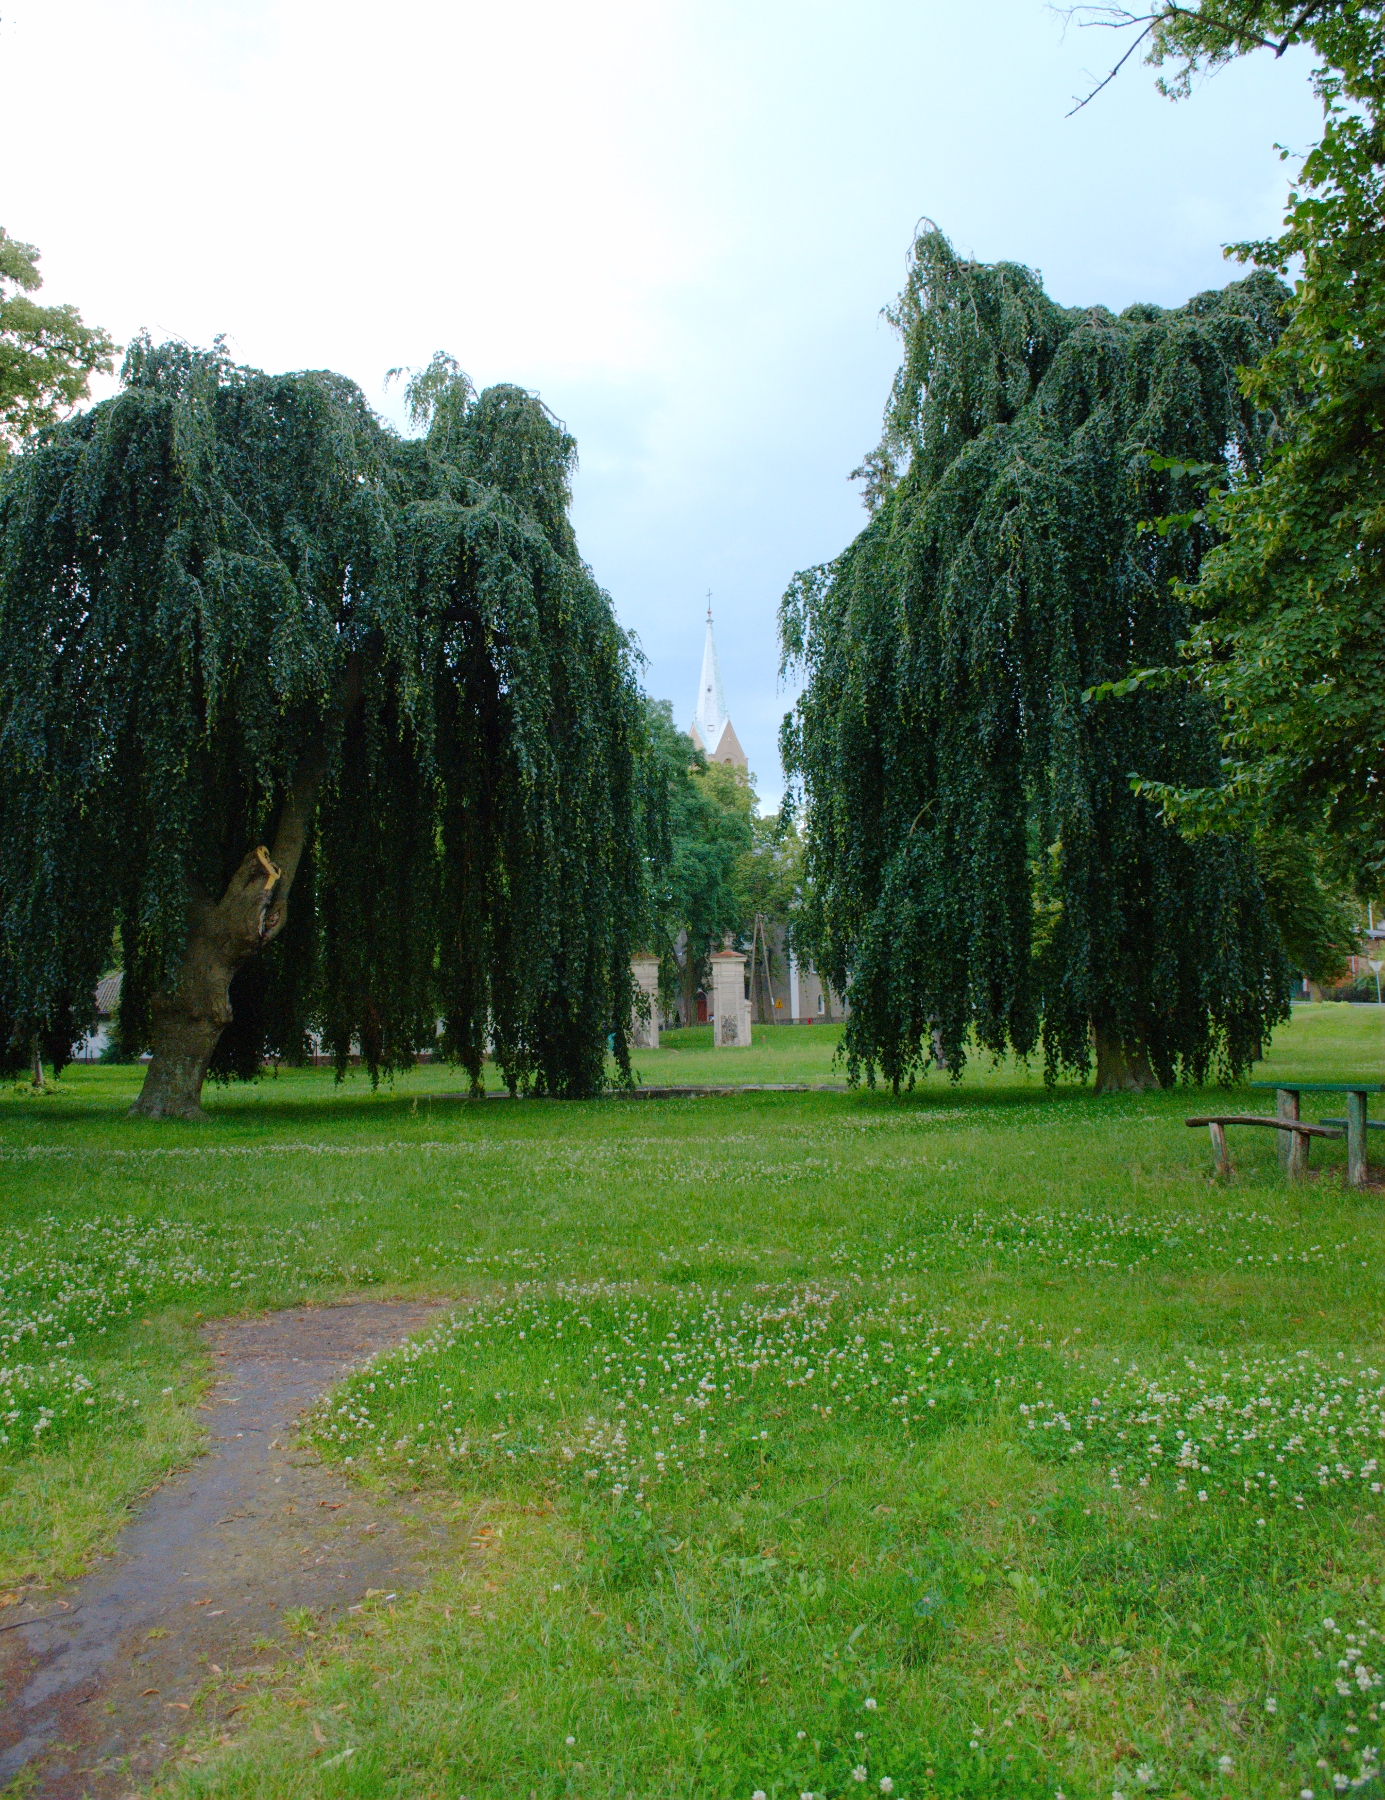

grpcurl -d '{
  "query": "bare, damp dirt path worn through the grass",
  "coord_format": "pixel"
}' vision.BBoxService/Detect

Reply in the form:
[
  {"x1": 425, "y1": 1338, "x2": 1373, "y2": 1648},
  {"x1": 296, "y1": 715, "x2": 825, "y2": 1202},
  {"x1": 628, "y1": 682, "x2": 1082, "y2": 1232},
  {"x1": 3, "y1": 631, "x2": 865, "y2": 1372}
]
[{"x1": 0, "y1": 1303, "x2": 465, "y2": 1800}]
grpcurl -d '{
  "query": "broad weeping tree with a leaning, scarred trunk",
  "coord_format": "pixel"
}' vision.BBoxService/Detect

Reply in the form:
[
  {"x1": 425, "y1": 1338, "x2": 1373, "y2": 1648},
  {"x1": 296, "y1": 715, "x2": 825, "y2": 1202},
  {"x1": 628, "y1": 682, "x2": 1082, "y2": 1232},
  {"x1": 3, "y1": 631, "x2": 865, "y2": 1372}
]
[{"x1": 0, "y1": 340, "x2": 648, "y2": 1118}]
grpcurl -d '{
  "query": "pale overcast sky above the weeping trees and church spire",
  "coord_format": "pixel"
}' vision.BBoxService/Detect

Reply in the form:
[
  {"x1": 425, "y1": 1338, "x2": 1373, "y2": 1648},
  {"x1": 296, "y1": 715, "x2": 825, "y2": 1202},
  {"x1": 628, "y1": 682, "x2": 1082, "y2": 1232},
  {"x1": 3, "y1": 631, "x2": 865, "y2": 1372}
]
[{"x1": 0, "y1": 0, "x2": 1318, "y2": 803}]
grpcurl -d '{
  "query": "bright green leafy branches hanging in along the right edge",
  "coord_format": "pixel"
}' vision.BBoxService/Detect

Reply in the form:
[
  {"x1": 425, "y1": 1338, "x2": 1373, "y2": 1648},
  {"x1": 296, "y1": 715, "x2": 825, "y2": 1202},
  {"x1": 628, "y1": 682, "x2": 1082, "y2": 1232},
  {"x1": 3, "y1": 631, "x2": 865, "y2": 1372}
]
[{"x1": 1079, "y1": 0, "x2": 1385, "y2": 893}]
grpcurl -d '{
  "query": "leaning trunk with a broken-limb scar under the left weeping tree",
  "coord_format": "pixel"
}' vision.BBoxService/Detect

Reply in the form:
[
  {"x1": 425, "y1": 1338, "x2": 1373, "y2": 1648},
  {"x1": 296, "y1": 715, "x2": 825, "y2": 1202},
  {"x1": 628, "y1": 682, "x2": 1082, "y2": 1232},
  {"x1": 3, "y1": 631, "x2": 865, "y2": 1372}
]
[{"x1": 130, "y1": 655, "x2": 362, "y2": 1120}]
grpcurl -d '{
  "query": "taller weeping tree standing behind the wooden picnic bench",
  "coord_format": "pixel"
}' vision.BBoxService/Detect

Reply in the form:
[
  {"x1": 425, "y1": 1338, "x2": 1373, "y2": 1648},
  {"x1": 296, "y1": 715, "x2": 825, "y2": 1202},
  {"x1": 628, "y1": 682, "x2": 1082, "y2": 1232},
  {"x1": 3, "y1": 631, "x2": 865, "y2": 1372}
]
[{"x1": 782, "y1": 227, "x2": 1288, "y2": 1089}]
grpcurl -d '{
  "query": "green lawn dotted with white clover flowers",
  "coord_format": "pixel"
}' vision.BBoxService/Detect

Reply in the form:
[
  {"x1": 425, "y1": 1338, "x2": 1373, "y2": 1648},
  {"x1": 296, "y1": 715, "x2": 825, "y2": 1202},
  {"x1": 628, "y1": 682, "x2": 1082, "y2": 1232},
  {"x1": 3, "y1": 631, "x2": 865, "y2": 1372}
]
[{"x1": 0, "y1": 1006, "x2": 1385, "y2": 1800}]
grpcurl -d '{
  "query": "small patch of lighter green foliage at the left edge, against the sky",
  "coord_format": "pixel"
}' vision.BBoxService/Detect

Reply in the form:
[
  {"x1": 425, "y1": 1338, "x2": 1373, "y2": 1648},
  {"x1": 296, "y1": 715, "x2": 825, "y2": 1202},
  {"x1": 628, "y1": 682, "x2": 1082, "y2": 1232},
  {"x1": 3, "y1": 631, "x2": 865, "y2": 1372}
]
[{"x1": 0, "y1": 227, "x2": 115, "y2": 463}]
